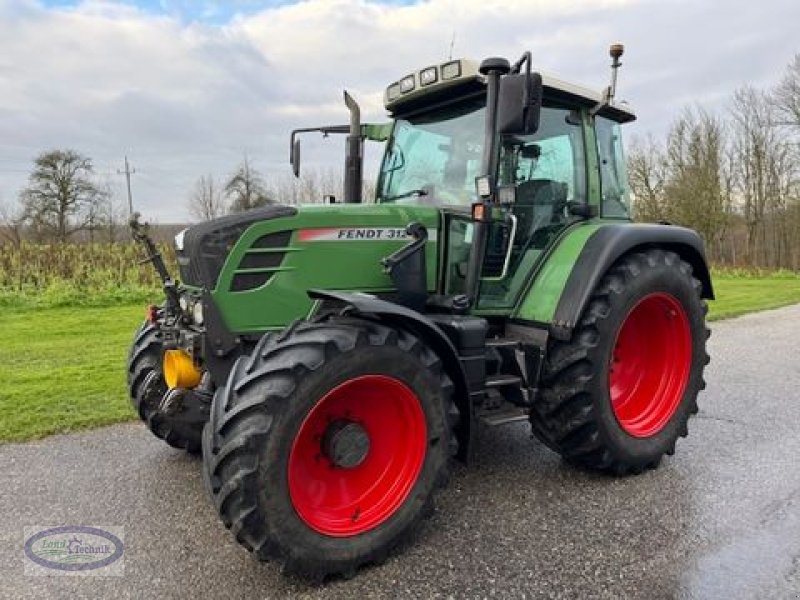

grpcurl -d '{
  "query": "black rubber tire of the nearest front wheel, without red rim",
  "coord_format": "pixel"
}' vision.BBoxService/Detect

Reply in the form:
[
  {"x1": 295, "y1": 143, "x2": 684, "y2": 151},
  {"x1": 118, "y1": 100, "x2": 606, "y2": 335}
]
[{"x1": 203, "y1": 317, "x2": 458, "y2": 581}]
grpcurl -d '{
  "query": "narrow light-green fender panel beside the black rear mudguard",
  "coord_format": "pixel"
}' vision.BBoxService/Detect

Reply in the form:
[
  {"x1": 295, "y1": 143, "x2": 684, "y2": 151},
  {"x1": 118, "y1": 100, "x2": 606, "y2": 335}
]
[{"x1": 512, "y1": 221, "x2": 603, "y2": 323}]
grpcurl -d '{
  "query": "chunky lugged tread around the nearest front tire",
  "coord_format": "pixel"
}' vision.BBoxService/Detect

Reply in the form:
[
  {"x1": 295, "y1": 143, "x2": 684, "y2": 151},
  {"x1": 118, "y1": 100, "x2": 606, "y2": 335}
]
[{"x1": 203, "y1": 317, "x2": 457, "y2": 580}]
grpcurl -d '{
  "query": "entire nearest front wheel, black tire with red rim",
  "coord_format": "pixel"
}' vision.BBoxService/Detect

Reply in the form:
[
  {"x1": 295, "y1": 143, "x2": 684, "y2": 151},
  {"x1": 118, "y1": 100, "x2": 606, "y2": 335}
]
[{"x1": 203, "y1": 319, "x2": 457, "y2": 579}]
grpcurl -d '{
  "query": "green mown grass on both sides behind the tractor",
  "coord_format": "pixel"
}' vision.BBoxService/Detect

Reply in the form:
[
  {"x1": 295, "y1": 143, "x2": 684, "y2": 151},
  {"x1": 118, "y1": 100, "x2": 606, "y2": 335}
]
[{"x1": 0, "y1": 274, "x2": 800, "y2": 442}]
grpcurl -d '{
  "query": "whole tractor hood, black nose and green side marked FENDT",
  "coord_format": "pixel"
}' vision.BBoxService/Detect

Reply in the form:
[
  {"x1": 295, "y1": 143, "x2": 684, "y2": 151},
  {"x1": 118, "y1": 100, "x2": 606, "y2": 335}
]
[{"x1": 187, "y1": 203, "x2": 441, "y2": 334}]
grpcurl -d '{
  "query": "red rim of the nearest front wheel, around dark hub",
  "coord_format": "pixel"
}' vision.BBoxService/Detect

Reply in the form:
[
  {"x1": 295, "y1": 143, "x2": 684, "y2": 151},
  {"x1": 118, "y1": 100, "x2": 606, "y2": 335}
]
[{"x1": 289, "y1": 375, "x2": 427, "y2": 537}]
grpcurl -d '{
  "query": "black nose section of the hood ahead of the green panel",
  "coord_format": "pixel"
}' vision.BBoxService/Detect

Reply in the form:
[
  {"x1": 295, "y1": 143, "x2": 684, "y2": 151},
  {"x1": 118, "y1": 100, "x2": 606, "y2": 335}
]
[{"x1": 175, "y1": 205, "x2": 297, "y2": 290}]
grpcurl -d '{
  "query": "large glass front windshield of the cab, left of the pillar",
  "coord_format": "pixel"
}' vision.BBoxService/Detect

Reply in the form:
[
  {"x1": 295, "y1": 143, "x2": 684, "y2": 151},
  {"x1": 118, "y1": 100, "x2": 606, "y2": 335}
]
[{"x1": 378, "y1": 96, "x2": 485, "y2": 206}]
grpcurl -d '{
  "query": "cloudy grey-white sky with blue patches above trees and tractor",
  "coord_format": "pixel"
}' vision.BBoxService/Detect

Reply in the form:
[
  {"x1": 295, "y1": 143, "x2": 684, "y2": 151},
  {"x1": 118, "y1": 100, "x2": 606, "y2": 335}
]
[{"x1": 0, "y1": 0, "x2": 800, "y2": 222}]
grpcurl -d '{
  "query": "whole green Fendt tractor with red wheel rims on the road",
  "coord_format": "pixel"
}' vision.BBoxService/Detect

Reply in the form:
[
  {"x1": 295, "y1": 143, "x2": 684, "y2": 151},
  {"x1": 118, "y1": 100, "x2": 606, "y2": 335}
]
[{"x1": 128, "y1": 45, "x2": 713, "y2": 577}]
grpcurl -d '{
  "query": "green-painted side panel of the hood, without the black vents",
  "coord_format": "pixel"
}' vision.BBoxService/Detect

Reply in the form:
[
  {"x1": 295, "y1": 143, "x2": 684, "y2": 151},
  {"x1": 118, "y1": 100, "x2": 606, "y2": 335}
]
[{"x1": 212, "y1": 204, "x2": 439, "y2": 333}]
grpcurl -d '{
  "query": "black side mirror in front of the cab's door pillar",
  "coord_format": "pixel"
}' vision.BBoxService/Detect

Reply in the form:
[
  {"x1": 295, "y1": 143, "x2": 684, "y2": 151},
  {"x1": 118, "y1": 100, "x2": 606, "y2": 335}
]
[{"x1": 497, "y1": 73, "x2": 542, "y2": 135}]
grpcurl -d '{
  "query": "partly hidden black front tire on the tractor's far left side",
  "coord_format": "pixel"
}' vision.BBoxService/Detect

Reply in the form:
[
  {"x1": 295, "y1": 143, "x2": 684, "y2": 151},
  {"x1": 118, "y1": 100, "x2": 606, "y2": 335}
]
[{"x1": 128, "y1": 321, "x2": 203, "y2": 454}]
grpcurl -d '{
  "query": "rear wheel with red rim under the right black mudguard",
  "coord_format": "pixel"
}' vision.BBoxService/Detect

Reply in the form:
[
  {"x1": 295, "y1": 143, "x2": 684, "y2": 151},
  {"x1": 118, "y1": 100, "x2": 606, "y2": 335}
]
[{"x1": 531, "y1": 249, "x2": 708, "y2": 474}]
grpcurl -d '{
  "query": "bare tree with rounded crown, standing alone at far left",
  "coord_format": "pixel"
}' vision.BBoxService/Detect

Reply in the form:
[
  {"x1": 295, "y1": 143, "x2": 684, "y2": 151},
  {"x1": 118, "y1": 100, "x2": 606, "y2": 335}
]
[{"x1": 20, "y1": 150, "x2": 106, "y2": 242}]
